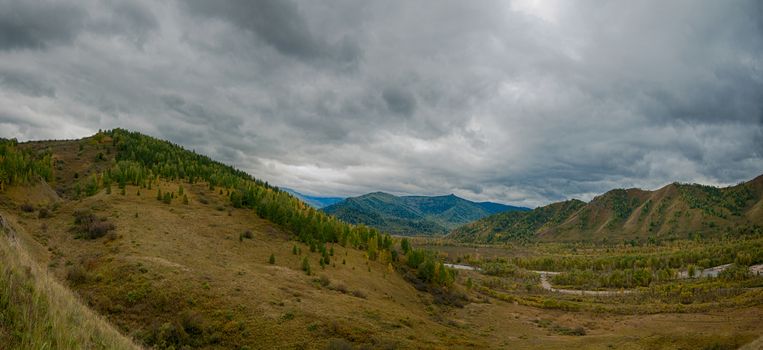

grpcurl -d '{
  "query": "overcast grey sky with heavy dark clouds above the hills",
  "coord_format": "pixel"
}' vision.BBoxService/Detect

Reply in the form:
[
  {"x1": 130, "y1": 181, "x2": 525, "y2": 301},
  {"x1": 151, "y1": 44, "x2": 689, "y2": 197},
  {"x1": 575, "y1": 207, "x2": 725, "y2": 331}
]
[{"x1": 0, "y1": 0, "x2": 763, "y2": 207}]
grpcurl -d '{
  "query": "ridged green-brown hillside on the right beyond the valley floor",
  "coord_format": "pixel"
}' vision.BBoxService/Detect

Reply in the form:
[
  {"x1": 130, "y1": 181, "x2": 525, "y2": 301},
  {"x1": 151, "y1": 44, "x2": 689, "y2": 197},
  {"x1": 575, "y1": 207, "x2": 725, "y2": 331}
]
[{"x1": 450, "y1": 176, "x2": 763, "y2": 243}]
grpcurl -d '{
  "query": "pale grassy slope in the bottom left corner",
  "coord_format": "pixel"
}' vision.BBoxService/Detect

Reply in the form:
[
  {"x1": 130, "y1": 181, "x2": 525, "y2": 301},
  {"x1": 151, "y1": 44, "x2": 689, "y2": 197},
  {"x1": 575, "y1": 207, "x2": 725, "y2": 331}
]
[{"x1": 0, "y1": 213, "x2": 139, "y2": 349}]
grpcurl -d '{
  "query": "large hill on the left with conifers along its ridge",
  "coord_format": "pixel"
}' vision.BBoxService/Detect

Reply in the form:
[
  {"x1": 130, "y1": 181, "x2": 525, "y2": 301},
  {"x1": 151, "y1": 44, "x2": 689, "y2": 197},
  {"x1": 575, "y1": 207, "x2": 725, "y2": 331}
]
[{"x1": 0, "y1": 130, "x2": 454, "y2": 349}]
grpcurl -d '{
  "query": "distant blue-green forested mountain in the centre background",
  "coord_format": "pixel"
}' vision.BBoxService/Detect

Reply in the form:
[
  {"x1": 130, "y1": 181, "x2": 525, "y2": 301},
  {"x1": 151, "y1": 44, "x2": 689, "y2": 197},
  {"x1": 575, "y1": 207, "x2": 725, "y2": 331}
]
[{"x1": 323, "y1": 192, "x2": 528, "y2": 235}]
